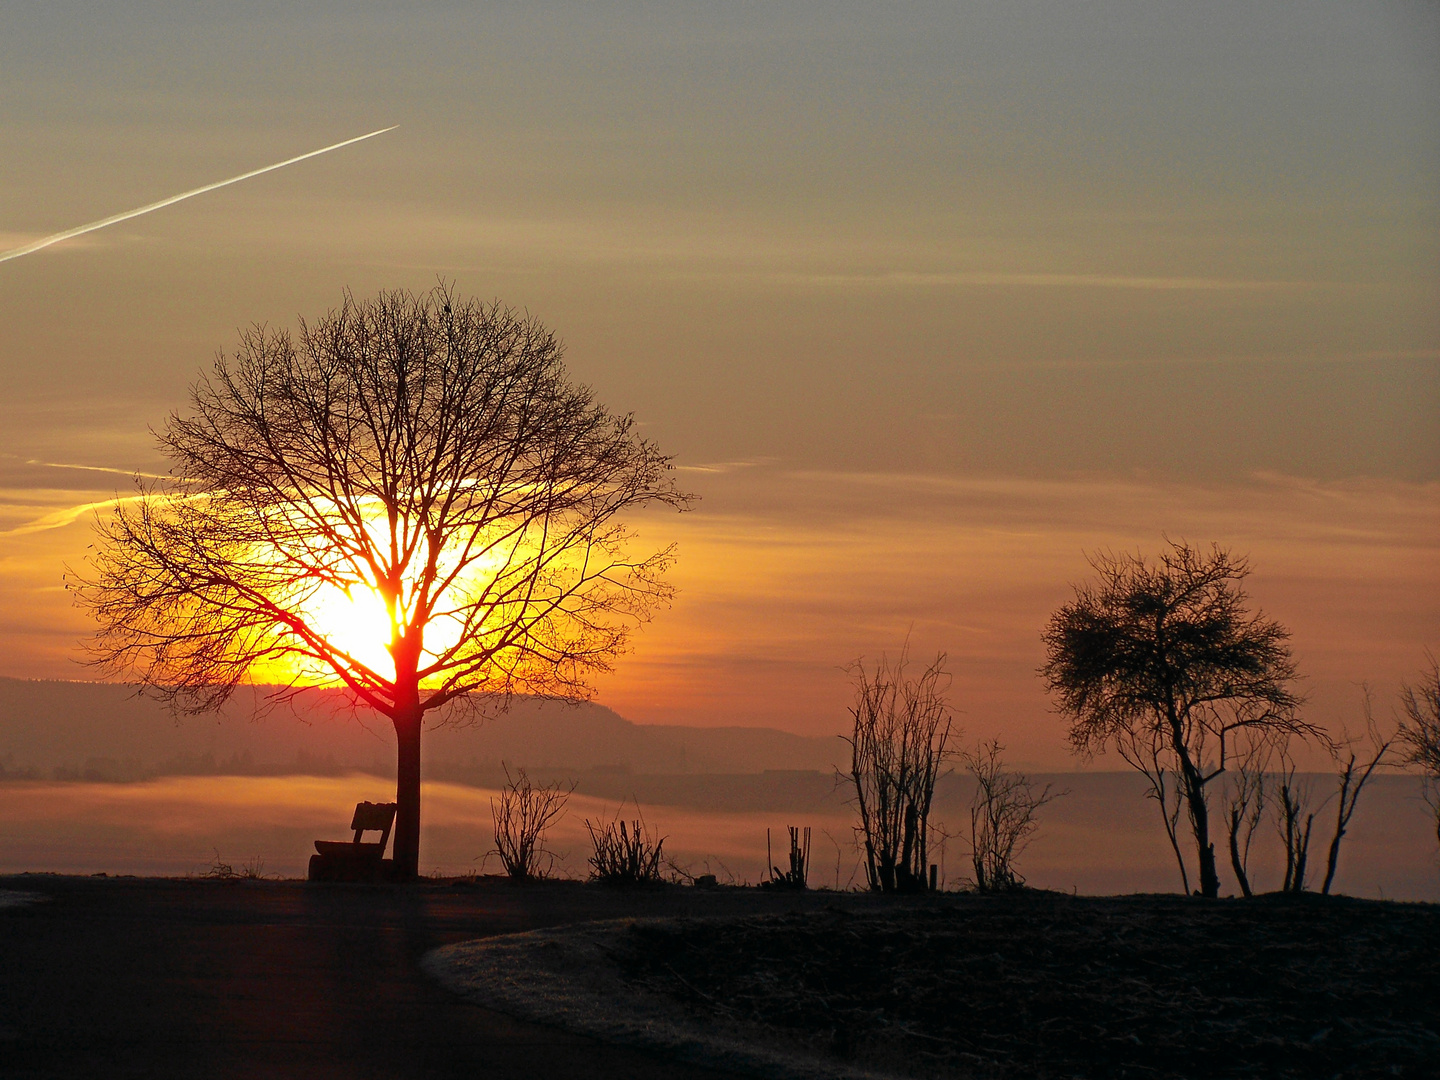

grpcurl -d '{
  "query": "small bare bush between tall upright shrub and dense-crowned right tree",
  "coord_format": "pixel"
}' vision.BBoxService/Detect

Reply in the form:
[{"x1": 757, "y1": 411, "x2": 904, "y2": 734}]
[{"x1": 960, "y1": 739, "x2": 1064, "y2": 893}]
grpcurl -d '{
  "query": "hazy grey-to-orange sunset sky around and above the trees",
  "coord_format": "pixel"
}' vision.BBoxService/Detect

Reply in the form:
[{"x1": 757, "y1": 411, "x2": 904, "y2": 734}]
[{"x1": 0, "y1": 0, "x2": 1440, "y2": 768}]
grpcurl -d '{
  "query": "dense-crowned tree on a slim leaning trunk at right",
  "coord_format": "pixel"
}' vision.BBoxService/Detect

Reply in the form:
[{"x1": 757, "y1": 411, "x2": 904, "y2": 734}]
[{"x1": 1041, "y1": 543, "x2": 1325, "y2": 896}]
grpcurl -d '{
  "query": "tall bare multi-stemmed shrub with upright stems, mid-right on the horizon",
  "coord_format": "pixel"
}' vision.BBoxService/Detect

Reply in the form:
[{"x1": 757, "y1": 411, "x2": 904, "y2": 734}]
[{"x1": 845, "y1": 652, "x2": 950, "y2": 893}]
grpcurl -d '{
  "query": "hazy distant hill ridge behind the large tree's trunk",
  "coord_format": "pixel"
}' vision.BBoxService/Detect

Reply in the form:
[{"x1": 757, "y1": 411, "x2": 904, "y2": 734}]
[{"x1": 0, "y1": 678, "x2": 845, "y2": 780}]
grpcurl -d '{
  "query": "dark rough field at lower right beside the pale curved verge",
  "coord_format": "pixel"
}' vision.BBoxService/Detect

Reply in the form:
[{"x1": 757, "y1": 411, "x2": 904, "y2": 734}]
[{"x1": 616, "y1": 894, "x2": 1440, "y2": 1079}]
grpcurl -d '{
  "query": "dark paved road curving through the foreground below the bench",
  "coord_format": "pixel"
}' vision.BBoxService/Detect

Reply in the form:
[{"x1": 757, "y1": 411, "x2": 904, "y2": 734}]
[{"x1": 0, "y1": 874, "x2": 840, "y2": 1080}]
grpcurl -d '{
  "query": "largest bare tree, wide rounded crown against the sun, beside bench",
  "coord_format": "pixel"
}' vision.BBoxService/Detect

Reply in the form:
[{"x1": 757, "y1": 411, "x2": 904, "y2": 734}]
[{"x1": 78, "y1": 287, "x2": 685, "y2": 877}]
